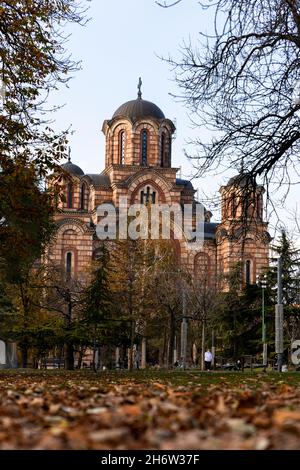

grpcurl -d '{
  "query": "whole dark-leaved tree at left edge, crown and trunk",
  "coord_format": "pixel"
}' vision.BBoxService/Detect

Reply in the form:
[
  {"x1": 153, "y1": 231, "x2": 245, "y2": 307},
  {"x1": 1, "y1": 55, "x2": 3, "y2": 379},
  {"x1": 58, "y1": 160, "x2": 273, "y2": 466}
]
[{"x1": 0, "y1": 165, "x2": 55, "y2": 367}]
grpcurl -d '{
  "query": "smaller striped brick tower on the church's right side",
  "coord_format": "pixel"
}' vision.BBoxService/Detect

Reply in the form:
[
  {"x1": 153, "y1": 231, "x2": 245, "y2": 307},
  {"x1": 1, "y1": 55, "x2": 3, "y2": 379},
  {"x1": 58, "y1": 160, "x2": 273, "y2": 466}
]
[{"x1": 216, "y1": 174, "x2": 270, "y2": 284}]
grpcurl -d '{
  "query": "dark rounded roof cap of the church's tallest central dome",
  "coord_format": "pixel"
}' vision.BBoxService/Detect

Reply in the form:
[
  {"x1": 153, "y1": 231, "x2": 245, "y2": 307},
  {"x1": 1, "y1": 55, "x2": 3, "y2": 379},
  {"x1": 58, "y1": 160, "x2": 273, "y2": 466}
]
[{"x1": 113, "y1": 98, "x2": 165, "y2": 120}]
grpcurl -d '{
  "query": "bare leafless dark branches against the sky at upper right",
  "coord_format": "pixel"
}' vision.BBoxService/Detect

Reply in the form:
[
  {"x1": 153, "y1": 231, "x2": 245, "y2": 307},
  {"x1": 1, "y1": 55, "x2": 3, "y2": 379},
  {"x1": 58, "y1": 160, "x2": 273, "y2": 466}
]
[{"x1": 163, "y1": 0, "x2": 300, "y2": 191}]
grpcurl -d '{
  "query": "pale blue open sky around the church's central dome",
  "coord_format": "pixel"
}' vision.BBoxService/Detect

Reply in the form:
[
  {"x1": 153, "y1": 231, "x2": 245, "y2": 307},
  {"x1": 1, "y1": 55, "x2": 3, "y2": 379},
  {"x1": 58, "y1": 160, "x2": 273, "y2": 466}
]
[{"x1": 50, "y1": 0, "x2": 300, "y2": 242}]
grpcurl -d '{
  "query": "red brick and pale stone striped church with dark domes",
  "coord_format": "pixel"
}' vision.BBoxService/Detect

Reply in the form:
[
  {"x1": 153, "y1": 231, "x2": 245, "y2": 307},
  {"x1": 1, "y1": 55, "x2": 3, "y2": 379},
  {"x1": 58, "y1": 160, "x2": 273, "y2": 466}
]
[{"x1": 49, "y1": 85, "x2": 270, "y2": 286}]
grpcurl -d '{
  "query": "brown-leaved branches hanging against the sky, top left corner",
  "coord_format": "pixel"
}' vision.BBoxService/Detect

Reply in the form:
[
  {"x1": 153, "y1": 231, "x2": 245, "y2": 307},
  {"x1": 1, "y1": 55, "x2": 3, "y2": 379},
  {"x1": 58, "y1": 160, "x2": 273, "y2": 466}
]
[{"x1": 0, "y1": 0, "x2": 88, "y2": 174}]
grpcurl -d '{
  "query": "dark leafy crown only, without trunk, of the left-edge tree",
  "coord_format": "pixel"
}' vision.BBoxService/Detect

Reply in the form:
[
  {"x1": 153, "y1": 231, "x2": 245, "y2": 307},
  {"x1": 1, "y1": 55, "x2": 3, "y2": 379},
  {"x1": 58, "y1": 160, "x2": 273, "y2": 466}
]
[{"x1": 0, "y1": 164, "x2": 55, "y2": 283}]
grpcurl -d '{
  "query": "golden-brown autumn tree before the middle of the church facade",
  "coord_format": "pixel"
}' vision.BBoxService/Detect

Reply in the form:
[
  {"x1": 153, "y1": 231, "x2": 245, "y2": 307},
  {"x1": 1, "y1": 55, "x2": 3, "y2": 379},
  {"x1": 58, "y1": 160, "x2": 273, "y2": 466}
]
[{"x1": 109, "y1": 239, "x2": 178, "y2": 368}]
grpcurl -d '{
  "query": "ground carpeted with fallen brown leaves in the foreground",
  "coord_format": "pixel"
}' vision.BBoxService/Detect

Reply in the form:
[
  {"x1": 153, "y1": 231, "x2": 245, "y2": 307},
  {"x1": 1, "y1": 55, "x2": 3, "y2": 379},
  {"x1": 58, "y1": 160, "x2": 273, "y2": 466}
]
[{"x1": 0, "y1": 370, "x2": 300, "y2": 450}]
